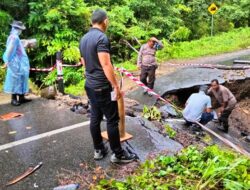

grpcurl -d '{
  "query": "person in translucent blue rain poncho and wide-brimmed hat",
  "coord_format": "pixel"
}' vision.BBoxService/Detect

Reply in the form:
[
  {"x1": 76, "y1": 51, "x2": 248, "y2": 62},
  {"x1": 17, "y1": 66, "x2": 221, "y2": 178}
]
[{"x1": 3, "y1": 21, "x2": 30, "y2": 106}]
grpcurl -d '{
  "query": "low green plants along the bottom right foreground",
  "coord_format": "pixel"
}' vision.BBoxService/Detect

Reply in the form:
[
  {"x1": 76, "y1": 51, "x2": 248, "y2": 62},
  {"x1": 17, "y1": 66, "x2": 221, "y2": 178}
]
[{"x1": 95, "y1": 146, "x2": 250, "y2": 190}]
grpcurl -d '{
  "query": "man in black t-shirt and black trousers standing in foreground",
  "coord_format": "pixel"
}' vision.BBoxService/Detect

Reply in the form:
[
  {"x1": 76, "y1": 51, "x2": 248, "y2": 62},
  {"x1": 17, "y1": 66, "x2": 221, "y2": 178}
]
[{"x1": 80, "y1": 9, "x2": 136, "y2": 163}]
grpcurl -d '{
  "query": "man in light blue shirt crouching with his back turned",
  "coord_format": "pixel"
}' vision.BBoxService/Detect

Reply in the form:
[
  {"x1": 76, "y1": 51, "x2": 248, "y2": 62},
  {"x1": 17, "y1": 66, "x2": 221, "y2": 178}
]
[{"x1": 183, "y1": 85, "x2": 213, "y2": 129}]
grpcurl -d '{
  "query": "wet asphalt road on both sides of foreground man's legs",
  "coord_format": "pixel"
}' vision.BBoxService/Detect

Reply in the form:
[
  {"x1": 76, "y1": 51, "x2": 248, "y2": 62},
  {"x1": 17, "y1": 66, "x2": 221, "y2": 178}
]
[{"x1": 0, "y1": 99, "x2": 182, "y2": 190}]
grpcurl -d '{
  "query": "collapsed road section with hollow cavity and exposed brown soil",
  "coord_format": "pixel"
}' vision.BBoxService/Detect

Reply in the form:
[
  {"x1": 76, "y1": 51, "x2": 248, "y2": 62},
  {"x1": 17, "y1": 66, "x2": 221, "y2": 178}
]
[{"x1": 128, "y1": 68, "x2": 250, "y2": 152}]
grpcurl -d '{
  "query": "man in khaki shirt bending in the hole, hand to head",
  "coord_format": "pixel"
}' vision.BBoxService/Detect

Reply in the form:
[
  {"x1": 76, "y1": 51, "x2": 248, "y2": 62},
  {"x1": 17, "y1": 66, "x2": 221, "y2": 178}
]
[{"x1": 208, "y1": 79, "x2": 237, "y2": 132}]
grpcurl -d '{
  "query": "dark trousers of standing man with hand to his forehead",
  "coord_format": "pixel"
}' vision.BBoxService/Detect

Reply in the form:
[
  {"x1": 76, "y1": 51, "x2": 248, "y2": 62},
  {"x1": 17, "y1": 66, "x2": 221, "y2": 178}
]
[{"x1": 140, "y1": 66, "x2": 157, "y2": 89}]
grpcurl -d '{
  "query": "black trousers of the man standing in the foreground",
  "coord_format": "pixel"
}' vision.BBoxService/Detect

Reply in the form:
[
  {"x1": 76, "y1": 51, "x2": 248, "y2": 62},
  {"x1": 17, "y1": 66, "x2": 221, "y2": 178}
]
[{"x1": 85, "y1": 86, "x2": 123, "y2": 155}]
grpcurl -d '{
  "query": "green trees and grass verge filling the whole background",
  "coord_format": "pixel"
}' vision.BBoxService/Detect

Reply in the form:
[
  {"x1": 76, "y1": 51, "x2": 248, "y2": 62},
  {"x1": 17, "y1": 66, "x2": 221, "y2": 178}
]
[{"x1": 0, "y1": 0, "x2": 250, "y2": 94}]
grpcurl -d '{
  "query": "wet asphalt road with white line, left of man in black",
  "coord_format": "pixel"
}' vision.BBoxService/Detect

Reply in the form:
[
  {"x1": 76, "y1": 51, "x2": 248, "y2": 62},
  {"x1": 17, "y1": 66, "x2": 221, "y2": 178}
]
[{"x1": 0, "y1": 99, "x2": 90, "y2": 190}]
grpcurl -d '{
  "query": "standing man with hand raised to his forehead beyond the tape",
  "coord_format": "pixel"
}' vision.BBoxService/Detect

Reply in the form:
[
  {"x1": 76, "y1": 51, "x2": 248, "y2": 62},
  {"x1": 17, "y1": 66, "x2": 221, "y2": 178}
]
[{"x1": 137, "y1": 37, "x2": 163, "y2": 96}]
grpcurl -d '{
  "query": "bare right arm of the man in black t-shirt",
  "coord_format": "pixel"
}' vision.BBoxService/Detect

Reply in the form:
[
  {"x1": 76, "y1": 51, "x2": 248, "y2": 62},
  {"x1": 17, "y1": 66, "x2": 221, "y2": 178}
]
[{"x1": 98, "y1": 52, "x2": 121, "y2": 100}]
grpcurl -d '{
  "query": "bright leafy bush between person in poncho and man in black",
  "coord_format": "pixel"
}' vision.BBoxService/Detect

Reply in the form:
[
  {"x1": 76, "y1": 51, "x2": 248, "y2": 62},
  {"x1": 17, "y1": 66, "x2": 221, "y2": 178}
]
[{"x1": 28, "y1": 0, "x2": 90, "y2": 64}]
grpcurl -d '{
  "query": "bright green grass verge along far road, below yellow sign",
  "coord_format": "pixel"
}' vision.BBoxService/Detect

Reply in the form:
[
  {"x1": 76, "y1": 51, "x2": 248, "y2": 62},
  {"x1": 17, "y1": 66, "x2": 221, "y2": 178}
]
[{"x1": 157, "y1": 28, "x2": 250, "y2": 61}]
